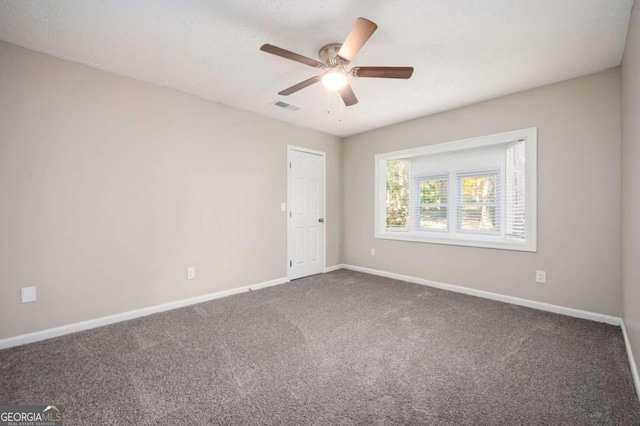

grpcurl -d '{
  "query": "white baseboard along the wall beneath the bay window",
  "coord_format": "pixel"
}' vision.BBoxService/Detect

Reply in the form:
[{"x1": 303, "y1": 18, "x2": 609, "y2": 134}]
[{"x1": 342, "y1": 265, "x2": 622, "y2": 326}]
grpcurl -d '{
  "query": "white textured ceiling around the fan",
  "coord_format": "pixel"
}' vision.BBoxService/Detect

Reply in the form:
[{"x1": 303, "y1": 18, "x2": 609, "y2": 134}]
[{"x1": 0, "y1": 0, "x2": 633, "y2": 136}]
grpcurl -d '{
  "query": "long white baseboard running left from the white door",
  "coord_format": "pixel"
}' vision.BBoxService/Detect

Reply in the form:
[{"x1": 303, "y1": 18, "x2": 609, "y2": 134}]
[{"x1": 0, "y1": 278, "x2": 289, "y2": 349}]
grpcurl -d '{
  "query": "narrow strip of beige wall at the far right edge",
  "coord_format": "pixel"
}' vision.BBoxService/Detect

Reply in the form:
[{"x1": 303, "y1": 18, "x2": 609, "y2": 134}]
[{"x1": 622, "y1": 2, "x2": 640, "y2": 382}]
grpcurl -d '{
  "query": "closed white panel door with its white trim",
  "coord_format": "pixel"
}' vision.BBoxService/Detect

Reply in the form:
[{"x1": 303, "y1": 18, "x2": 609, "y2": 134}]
[{"x1": 287, "y1": 147, "x2": 325, "y2": 280}]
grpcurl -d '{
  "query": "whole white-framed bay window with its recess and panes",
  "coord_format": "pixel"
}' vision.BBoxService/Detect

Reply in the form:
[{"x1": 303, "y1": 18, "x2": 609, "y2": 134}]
[{"x1": 376, "y1": 128, "x2": 537, "y2": 251}]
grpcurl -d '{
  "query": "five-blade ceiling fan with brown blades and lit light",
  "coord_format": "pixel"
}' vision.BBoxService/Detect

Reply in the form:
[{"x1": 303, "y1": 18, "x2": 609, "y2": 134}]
[{"x1": 260, "y1": 18, "x2": 413, "y2": 106}]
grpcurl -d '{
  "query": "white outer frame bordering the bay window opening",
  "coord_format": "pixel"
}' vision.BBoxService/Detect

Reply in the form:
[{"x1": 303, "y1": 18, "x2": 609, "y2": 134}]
[{"x1": 374, "y1": 127, "x2": 538, "y2": 252}]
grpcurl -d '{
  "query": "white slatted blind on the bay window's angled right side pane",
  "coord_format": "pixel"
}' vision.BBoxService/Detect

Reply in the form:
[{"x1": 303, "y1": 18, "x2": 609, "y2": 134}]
[{"x1": 505, "y1": 141, "x2": 526, "y2": 240}]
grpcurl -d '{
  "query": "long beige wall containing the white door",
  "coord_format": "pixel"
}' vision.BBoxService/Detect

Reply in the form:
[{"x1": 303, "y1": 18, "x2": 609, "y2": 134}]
[{"x1": 0, "y1": 43, "x2": 342, "y2": 339}]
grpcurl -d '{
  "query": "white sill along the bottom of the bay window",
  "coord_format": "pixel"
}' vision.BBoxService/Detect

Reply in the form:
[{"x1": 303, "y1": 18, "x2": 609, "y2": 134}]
[{"x1": 376, "y1": 231, "x2": 538, "y2": 252}]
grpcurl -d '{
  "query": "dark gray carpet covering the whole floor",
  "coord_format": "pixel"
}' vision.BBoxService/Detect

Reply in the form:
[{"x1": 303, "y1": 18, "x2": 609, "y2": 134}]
[{"x1": 0, "y1": 270, "x2": 640, "y2": 425}]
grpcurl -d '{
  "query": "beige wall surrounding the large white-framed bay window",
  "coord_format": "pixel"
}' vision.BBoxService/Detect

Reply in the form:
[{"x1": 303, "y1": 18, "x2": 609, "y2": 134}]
[{"x1": 343, "y1": 69, "x2": 624, "y2": 316}]
